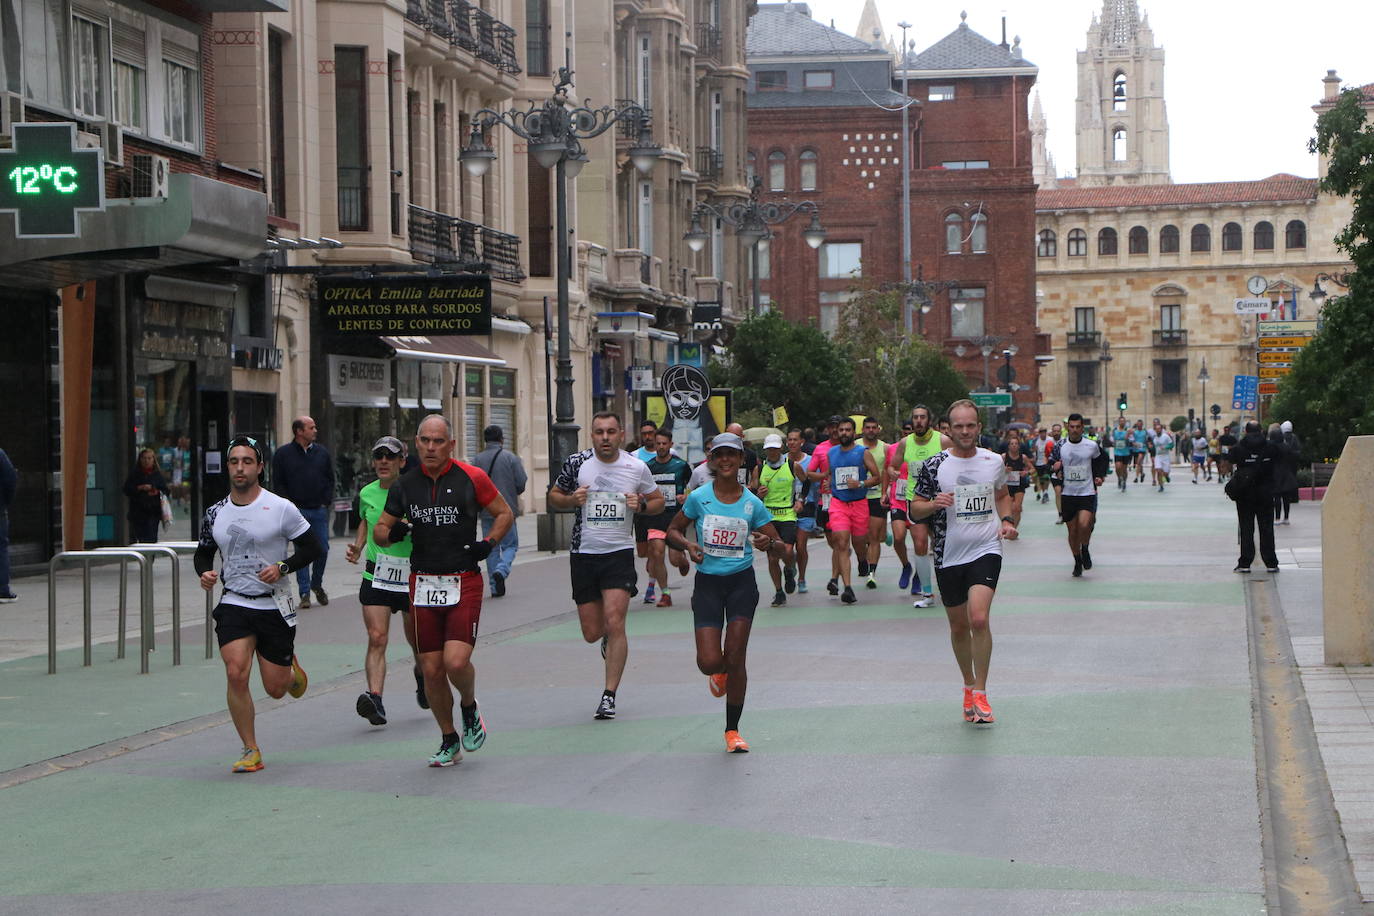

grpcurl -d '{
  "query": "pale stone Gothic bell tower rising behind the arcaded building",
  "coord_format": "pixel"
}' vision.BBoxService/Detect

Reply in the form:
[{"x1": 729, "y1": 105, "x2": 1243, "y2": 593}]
[{"x1": 1074, "y1": 0, "x2": 1171, "y2": 187}]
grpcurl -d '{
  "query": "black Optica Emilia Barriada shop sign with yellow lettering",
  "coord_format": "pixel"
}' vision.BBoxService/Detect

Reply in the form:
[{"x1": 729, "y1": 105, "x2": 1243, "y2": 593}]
[{"x1": 319, "y1": 277, "x2": 492, "y2": 336}]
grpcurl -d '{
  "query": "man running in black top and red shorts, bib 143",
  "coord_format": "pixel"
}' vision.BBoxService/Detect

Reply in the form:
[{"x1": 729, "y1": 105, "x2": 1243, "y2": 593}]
[{"x1": 372, "y1": 413, "x2": 515, "y2": 766}]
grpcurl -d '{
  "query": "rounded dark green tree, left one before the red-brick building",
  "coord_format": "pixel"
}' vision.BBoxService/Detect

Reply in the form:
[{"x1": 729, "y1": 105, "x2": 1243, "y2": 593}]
[{"x1": 710, "y1": 312, "x2": 853, "y2": 427}]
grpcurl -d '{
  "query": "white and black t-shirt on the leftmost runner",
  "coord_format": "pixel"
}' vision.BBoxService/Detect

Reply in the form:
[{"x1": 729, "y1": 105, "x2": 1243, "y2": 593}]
[{"x1": 201, "y1": 490, "x2": 311, "y2": 611}]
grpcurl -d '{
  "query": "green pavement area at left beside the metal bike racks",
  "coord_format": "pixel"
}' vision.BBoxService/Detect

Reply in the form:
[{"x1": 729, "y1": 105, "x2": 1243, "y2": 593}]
[{"x1": 0, "y1": 637, "x2": 411, "y2": 772}]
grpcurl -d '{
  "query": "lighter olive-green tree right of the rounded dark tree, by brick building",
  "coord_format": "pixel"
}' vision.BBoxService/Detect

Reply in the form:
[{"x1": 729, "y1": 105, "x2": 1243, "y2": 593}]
[{"x1": 835, "y1": 288, "x2": 969, "y2": 434}]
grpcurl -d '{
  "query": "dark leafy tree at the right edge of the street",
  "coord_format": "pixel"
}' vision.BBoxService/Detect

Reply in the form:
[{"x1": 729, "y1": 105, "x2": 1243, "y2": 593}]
[{"x1": 1270, "y1": 89, "x2": 1374, "y2": 457}]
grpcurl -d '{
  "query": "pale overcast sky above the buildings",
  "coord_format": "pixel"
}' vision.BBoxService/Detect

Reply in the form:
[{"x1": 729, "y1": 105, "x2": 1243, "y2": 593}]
[{"x1": 809, "y1": 0, "x2": 1374, "y2": 183}]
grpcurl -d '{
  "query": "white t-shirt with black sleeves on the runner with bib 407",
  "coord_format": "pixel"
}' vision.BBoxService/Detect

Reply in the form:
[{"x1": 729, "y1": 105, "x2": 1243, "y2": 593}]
[{"x1": 915, "y1": 448, "x2": 1007, "y2": 569}]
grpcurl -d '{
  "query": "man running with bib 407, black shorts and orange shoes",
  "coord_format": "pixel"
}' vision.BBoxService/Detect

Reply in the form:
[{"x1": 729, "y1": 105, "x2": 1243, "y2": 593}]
[{"x1": 907, "y1": 400, "x2": 1017, "y2": 724}]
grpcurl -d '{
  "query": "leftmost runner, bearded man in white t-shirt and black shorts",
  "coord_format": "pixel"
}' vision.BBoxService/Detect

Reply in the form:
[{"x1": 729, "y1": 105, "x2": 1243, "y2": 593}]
[{"x1": 194, "y1": 435, "x2": 319, "y2": 773}]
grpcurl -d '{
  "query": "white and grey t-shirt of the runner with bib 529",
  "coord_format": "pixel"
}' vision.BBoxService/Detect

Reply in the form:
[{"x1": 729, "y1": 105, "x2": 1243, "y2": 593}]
[{"x1": 554, "y1": 449, "x2": 658, "y2": 553}]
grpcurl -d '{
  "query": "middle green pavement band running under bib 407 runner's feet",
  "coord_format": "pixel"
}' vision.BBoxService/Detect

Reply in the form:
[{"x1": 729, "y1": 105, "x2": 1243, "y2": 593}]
[{"x1": 159, "y1": 678, "x2": 1254, "y2": 769}]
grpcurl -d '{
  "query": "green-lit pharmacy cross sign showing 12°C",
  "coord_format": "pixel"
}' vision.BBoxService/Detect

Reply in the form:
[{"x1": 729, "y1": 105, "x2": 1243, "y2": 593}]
[{"x1": 0, "y1": 124, "x2": 104, "y2": 239}]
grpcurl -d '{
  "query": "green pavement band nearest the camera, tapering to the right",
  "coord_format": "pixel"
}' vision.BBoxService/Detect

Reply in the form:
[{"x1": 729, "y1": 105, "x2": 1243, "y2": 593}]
[{"x1": 4, "y1": 774, "x2": 1241, "y2": 897}]
